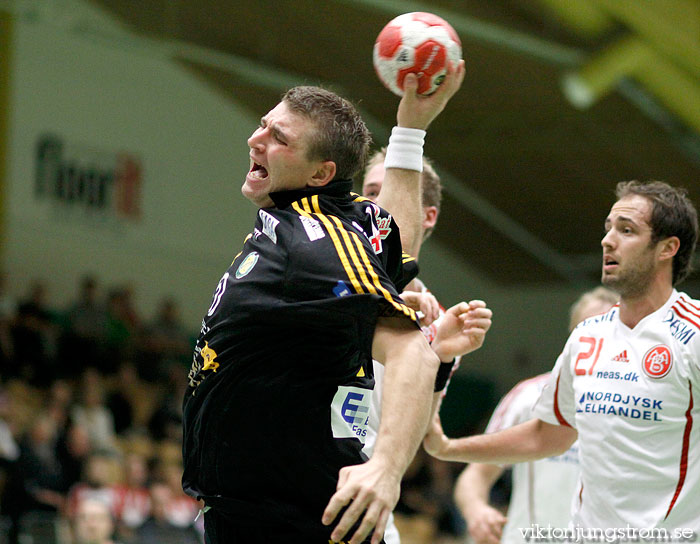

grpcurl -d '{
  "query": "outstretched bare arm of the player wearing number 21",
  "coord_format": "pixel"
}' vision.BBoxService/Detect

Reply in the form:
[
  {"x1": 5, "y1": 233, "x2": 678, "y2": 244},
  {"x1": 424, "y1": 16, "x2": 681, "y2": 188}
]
[{"x1": 433, "y1": 419, "x2": 576, "y2": 464}]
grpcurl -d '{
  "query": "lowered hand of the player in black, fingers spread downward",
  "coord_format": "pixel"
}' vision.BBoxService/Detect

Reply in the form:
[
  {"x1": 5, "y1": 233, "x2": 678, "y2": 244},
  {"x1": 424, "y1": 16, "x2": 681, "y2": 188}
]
[{"x1": 321, "y1": 457, "x2": 401, "y2": 544}]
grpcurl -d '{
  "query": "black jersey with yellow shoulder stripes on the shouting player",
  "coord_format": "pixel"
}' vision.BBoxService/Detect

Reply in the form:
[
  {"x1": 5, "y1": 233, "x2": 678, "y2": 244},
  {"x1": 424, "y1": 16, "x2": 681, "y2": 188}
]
[{"x1": 183, "y1": 180, "x2": 418, "y2": 534}]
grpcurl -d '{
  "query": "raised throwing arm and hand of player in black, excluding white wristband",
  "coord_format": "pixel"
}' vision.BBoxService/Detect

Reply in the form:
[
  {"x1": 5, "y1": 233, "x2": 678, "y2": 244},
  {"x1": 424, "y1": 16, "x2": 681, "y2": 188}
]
[{"x1": 377, "y1": 61, "x2": 464, "y2": 257}]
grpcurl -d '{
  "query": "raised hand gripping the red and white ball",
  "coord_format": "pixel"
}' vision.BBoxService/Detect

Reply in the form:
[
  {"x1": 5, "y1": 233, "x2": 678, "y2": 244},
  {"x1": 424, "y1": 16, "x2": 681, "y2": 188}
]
[{"x1": 396, "y1": 60, "x2": 464, "y2": 130}]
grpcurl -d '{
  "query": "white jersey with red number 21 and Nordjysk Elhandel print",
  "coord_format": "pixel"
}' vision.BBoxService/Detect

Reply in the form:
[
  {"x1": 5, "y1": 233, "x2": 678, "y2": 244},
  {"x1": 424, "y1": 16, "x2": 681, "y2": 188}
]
[{"x1": 534, "y1": 290, "x2": 700, "y2": 531}]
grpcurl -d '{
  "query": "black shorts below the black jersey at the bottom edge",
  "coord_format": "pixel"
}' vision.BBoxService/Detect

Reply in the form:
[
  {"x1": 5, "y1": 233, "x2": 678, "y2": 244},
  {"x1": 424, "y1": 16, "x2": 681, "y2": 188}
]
[{"x1": 204, "y1": 508, "x2": 384, "y2": 544}]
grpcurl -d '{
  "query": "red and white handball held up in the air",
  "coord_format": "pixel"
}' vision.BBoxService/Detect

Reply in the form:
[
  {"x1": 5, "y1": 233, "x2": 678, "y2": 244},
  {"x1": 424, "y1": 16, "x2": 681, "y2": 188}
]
[{"x1": 373, "y1": 11, "x2": 462, "y2": 96}]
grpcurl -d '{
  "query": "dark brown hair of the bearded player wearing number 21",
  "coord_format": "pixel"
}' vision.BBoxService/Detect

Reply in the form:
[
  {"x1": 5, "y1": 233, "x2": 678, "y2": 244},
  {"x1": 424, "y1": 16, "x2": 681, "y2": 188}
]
[{"x1": 615, "y1": 181, "x2": 698, "y2": 286}]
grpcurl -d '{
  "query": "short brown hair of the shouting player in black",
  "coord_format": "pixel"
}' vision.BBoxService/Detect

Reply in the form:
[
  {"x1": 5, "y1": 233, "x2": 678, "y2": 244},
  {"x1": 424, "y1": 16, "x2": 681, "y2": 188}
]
[{"x1": 282, "y1": 86, "x2": 372, "y2": 179}]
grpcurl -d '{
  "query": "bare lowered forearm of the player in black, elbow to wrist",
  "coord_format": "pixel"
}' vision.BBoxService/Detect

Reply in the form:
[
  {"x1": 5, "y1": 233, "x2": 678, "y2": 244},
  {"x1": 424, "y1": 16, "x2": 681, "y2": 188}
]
[{"x1": 372, "y1": 333, "x2": 439, "y2": 474}]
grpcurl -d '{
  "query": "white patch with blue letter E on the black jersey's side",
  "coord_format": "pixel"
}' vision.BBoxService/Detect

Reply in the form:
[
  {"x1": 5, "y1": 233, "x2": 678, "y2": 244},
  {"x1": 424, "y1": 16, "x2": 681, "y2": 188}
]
[{"x1": 331, "y1": 385, "x2": 372, "y2": 444}]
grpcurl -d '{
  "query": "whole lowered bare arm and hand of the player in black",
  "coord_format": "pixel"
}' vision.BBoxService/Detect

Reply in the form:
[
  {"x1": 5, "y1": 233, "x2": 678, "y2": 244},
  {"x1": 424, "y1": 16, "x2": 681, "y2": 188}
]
[{"x1": 322, "y1": 318, "x2": 439, "y2": 544}]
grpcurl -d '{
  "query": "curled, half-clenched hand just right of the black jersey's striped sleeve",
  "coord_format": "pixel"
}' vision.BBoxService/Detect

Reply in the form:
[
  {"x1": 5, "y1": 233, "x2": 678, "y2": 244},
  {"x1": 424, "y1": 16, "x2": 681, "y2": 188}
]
[{"x1": 432, "y1": 300, "x2": 493, "y2": 362}]
